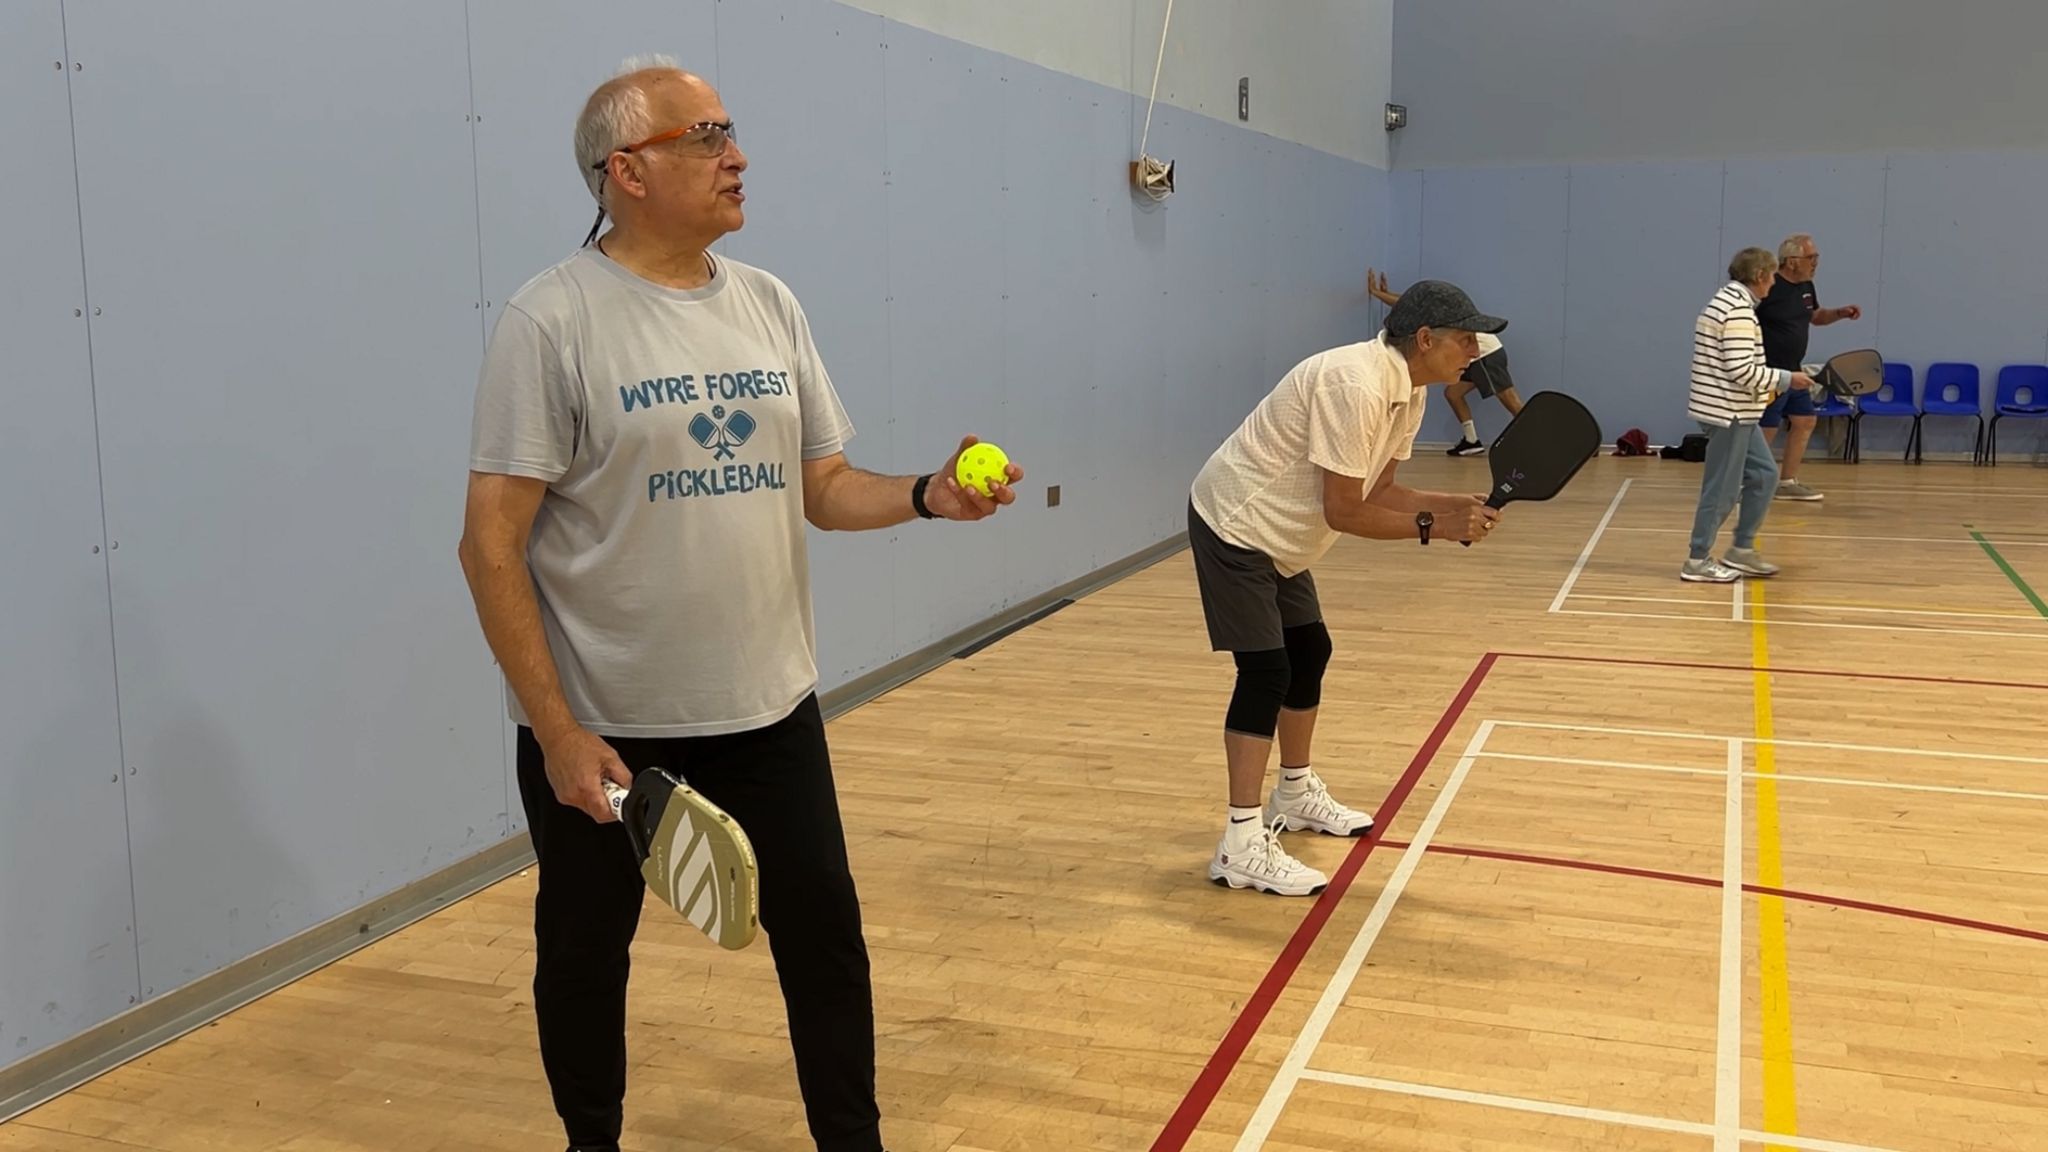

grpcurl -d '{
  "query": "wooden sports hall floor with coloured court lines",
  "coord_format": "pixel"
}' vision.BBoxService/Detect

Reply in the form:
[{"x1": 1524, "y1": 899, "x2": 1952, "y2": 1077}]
[{"x1": 0, "y1": 453, "x2": 2048, "y2": 1152}]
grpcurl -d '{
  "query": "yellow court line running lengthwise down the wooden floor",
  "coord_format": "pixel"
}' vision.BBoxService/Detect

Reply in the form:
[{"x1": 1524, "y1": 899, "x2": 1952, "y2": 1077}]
[{"x1": 1749, "y1": 584, "x2": 1798, "y2": 1152}]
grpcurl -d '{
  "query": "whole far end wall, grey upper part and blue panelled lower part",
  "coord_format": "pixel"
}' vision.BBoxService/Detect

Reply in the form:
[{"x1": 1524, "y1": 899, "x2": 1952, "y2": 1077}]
[{"x1": 1391, "y1": 0, "x2": 2048, "y2": 461}]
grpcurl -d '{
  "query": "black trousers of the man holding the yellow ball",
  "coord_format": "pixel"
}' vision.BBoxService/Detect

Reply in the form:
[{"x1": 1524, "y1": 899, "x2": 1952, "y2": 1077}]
[{"x1": 518, "y1": 695, "x2": 883, "y2": 1152}]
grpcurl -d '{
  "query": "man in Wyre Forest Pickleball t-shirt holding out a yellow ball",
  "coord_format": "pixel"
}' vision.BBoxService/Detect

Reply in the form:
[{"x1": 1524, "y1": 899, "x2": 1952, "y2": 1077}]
[{"x1": 461, "y1": 57, "x2": 1022, "y2": 1152}]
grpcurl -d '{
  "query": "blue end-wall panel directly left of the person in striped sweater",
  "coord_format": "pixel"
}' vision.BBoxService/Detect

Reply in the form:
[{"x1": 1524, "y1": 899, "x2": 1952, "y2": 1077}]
[{"x1": 1556, "y1": 164, "x2": 1729, "y2": 443}]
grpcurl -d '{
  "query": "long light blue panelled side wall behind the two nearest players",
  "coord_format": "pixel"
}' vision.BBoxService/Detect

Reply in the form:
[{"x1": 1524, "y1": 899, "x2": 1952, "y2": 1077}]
[{"x1": 0, "y1": 0, "x2": 1393, "y2": 1064}]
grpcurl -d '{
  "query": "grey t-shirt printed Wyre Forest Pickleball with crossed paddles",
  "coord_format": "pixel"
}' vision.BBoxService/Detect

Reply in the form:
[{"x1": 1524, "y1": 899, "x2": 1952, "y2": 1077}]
[{"x1": 469, "y1": 248, "x2": 852, "y2": 736}]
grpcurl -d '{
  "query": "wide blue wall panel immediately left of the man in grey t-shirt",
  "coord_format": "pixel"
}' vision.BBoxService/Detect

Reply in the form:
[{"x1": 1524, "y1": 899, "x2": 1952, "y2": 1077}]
[{"x1": 68, "y1": 0, "x2": 506, "y2": 994}]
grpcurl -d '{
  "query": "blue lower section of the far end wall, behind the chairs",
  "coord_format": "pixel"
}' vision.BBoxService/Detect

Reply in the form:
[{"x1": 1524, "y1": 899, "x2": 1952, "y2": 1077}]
[{"x1": 1393, "y1": 152, "x2": 2048, "y2": 453}]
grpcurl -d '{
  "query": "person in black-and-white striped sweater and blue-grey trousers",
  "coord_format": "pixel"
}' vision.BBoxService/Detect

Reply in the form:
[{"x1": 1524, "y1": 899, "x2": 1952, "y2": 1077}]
[{"x1": 1679, "y1": 248, "x2": 1812, "y2": 584}]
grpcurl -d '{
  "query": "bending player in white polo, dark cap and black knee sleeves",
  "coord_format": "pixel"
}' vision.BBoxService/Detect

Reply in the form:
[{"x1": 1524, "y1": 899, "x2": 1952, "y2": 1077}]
[{"x1": 1188, "y1": 281, "x2": 1507, "y2": 896}]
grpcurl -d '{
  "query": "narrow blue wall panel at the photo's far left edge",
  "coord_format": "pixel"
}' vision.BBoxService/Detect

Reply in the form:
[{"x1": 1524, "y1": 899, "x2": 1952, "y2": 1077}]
[{"x1": 0, "y1": 0, "x2": 137, "y2": 1064}]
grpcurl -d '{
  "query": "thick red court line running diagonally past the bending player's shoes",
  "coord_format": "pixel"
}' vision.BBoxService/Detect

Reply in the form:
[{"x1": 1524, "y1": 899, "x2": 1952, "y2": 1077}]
[{"x1": 1151, "y1": 652, "x2": 1495, "y2": 1152}]
